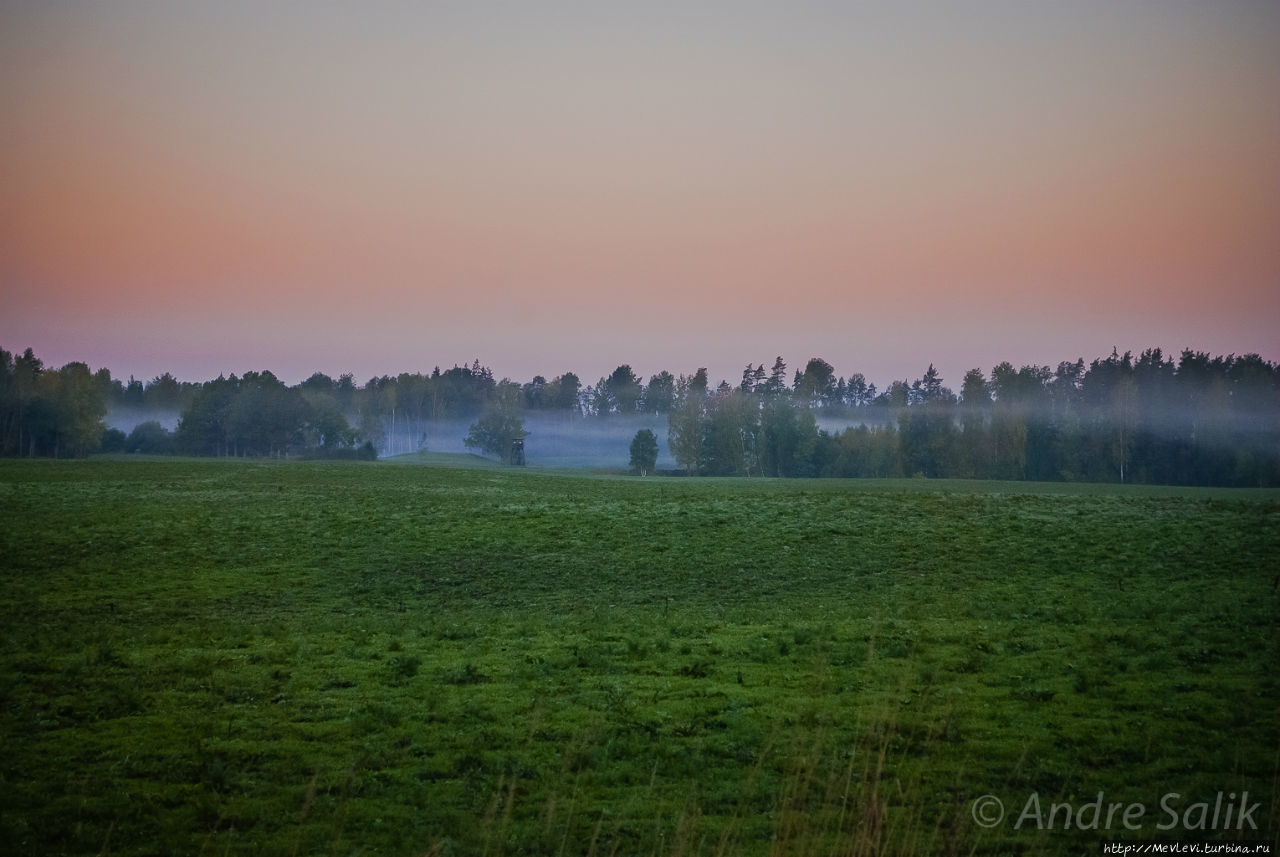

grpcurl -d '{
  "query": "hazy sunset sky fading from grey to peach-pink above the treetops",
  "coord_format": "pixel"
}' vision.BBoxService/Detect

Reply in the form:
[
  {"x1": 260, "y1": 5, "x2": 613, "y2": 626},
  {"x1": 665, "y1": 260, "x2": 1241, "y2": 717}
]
[{"x1": 0, "y1": 0, "x2": 1280, "y2": 389}]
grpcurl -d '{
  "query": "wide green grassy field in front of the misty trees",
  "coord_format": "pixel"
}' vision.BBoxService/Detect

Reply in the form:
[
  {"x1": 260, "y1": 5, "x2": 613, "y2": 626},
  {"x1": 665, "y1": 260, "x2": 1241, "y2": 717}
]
[{"x1": 0, "y1": 459, "x2": 1280, "y2": 854}]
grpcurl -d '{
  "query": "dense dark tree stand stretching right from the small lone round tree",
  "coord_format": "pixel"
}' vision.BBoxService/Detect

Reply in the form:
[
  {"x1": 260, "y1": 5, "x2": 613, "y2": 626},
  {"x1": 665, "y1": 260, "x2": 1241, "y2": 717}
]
[{"x1": 668, "y1": 348, "x2": 1280, "y2": 486}]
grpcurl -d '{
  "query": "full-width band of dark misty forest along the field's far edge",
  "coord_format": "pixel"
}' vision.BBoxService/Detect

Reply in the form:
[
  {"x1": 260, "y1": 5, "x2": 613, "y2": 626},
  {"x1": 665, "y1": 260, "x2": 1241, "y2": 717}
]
[{"x1": 0, "y1": 348, "x2": 1280, "y2": 486}]
